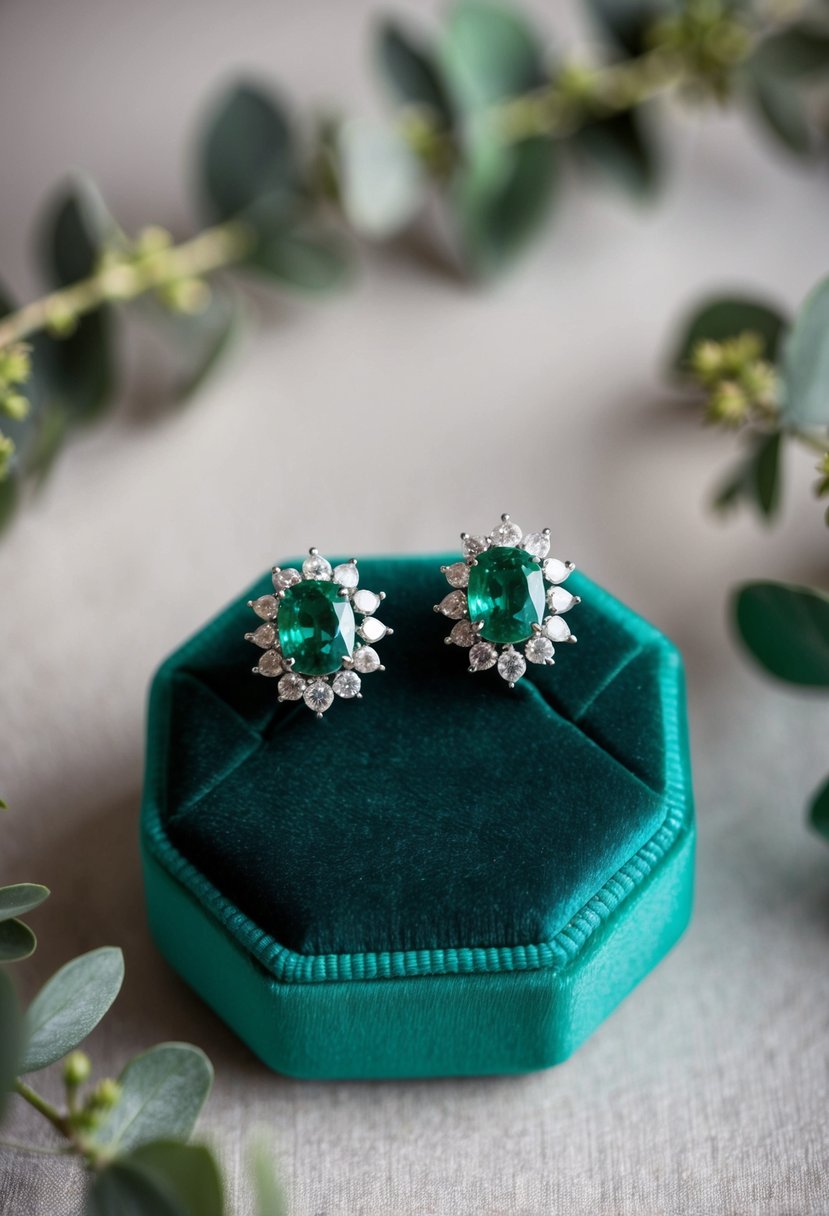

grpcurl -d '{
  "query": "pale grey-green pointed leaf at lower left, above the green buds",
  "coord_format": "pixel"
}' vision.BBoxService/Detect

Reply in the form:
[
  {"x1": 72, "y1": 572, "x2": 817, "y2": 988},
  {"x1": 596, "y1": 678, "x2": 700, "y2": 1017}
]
[{"x1": 22, "y1": 946, "x2": 124, "y2": 1073}]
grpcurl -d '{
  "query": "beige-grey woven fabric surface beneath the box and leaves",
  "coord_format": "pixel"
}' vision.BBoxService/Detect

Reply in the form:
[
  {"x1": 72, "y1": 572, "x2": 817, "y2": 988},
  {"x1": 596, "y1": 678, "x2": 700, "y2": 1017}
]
[{"x1": 0, "y1": 0, "x2": 829, "y2": 1216}]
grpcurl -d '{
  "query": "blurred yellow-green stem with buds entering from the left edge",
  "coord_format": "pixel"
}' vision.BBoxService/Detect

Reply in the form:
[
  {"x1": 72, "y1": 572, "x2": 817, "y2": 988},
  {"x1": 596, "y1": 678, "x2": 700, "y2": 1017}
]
[{"x1": 0, "y1": 220, "x2": 253, "y2": 349}]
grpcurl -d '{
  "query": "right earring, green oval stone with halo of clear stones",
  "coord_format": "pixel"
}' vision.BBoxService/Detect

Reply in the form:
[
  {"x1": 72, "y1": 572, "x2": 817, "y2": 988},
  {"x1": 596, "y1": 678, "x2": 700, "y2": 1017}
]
[{"x1": 435, "y1": 516, "x2": 581, "y2": 688}]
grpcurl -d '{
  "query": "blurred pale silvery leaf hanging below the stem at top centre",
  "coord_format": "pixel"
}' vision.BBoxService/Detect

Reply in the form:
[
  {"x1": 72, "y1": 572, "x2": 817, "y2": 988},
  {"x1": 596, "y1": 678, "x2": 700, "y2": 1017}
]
[{"x1": 337, "y1": 119, "x2": 424, "y2": 240}]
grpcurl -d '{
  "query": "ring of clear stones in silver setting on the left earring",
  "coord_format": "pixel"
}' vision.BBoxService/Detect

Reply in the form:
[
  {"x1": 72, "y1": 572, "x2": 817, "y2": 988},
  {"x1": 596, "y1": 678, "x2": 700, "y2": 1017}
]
[{"x1": 244, "y1": 548, "x2": 394, "y2": 717}]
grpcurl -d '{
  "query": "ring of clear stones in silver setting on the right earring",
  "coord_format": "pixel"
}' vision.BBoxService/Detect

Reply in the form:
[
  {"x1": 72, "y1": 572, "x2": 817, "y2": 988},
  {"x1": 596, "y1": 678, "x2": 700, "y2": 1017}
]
[{"x1": 434, "y1": 514, "x2": 581, "y2": 688}]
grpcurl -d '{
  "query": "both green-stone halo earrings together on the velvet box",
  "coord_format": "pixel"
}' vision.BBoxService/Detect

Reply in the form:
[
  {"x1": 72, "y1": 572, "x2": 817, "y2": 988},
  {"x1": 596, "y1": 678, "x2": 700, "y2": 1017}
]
[{"x1": 244, "y1": 514, "x2": 581, "y2": 717}]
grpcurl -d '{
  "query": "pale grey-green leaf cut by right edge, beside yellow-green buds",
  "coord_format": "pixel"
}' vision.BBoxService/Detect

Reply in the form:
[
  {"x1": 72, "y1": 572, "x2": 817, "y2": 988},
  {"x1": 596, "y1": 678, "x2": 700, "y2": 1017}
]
[{"x1": 783, "y1": 278, "x2": 829, "y2": 428}]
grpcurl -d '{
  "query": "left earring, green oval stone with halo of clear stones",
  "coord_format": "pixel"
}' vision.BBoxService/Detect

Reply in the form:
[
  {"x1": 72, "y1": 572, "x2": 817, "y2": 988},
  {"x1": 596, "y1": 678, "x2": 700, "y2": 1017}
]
[{"x1": 244, "y1": 548, "x2": 394, "y2": 717}]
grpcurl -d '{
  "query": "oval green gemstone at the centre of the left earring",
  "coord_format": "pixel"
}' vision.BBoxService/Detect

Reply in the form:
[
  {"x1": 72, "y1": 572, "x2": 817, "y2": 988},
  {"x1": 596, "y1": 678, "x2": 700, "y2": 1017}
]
[{"x1": 278, "y1": 581, "x2": 354, "y2": 676}]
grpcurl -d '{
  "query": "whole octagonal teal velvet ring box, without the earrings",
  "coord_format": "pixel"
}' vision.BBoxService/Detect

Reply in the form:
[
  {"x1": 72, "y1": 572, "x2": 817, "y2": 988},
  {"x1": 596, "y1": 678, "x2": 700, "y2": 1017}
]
[{"x1": 142, "y1": 557, "x2": 694, "y2": 1077}]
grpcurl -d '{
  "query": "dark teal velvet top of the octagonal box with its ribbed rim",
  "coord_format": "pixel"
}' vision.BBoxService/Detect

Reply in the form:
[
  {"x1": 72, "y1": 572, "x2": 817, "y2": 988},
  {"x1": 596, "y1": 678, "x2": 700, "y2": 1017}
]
[{"x1": 145, "y1": 557, "x2": 690, "y2": 1075}]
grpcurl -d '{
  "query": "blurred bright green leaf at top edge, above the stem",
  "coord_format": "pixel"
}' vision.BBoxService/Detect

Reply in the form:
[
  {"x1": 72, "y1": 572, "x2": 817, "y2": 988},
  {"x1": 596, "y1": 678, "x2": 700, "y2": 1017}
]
[{"x1": 440, "y1": 0, "x2": 546, "y2": 111}]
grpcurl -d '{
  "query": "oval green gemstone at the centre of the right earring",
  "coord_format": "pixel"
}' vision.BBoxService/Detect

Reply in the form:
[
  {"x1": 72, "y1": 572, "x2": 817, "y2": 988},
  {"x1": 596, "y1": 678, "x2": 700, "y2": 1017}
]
[{"x1": 467, "y1": 546, "x2": 545, "y2": 642}]
